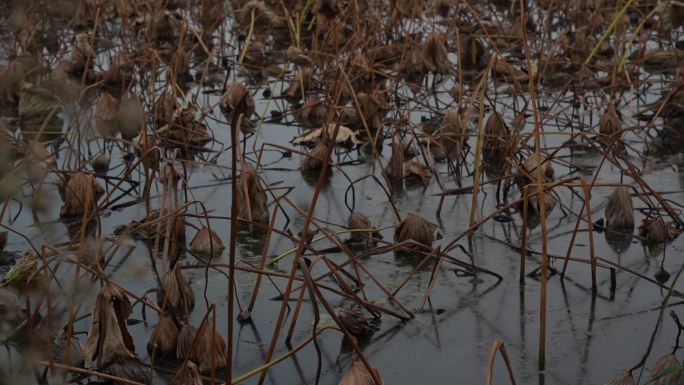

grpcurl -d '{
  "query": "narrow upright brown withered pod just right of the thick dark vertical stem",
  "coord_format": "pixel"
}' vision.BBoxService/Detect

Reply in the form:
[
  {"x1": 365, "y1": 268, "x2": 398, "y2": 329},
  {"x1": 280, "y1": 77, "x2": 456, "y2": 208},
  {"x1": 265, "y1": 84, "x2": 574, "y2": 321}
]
[{"x1": 238, "y1": 161, "x2": 269, "y2": 225}]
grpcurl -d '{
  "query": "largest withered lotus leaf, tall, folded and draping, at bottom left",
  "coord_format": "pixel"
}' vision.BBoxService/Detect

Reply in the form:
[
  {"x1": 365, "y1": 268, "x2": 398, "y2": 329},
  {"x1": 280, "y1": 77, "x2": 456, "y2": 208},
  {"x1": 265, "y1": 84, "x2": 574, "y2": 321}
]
[{"x1": 85, "y1": 283, "x2": 135, "y2": 369}]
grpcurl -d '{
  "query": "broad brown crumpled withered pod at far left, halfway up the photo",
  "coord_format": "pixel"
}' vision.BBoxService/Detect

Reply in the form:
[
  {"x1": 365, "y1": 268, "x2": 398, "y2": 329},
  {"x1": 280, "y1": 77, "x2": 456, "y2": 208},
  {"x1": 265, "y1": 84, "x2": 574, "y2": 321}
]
[{"x1": 60, "y1": 172, "x2": 104, "y2": 217}]
